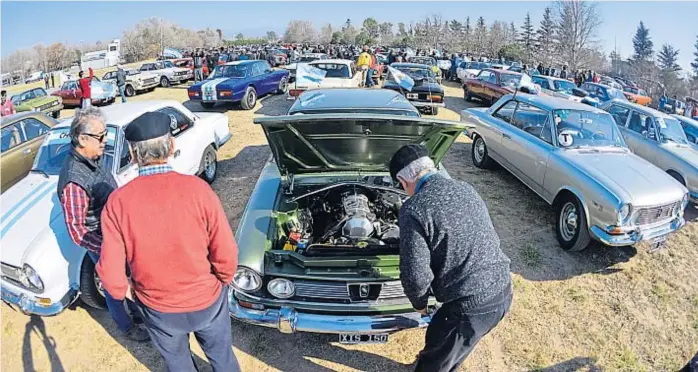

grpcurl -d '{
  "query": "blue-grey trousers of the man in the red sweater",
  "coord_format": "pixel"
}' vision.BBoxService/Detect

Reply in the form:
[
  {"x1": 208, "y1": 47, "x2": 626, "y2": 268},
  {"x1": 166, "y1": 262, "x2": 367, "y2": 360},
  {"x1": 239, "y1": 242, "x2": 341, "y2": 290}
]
[{"x1": 138, "y1": 286, "x2": 240, "y2": 372}]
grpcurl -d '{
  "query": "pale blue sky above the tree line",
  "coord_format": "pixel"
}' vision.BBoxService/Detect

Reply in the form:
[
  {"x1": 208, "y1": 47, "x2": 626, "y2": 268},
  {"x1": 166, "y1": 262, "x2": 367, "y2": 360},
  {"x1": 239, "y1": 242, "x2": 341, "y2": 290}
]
[{"x1": 0, "y1": 1, "x2": 698, "y2": 69}]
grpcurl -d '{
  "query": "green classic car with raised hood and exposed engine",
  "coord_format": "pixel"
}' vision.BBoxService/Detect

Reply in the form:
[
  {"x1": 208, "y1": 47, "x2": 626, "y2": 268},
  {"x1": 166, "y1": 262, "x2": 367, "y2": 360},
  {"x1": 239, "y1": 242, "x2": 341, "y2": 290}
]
[{"x1": 228, "y1": 113, "x2": 467, "y2": 343}]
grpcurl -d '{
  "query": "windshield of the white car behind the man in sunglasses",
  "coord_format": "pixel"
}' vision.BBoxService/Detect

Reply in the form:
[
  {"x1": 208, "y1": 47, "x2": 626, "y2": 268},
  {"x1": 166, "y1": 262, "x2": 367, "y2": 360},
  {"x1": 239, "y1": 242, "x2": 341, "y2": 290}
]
[{"x1": 33, "y1": 126, "x2": 116, "y2": 175}]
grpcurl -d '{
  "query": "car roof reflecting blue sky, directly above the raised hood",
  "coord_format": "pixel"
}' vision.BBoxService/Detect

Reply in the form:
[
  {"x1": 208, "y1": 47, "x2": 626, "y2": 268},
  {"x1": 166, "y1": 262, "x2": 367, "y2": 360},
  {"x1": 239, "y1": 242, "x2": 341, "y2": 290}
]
[{"x1": 289, "y1": 88, "x2": 417, "y2": 113}]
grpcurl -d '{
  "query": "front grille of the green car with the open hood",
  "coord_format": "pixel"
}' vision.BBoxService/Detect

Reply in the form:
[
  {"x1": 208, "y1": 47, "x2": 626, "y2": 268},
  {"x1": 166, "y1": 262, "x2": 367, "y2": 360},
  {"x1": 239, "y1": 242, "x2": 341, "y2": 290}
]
[{"x1": 294, "y1": 280, "x2": 405, "y2": 301}]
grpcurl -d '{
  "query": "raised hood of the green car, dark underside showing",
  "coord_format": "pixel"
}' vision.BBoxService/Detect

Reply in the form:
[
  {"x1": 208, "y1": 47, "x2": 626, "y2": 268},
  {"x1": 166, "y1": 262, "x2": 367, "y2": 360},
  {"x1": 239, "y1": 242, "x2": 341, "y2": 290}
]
[{"x1": 254, "y1": 113, "x2": 470, "y2": 174}]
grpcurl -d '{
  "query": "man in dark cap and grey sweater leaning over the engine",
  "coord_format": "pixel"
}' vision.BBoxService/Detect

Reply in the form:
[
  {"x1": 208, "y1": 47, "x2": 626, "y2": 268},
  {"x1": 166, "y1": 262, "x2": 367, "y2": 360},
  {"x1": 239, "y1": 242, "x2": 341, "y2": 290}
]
[{"x1": 390, "y1": 145, "x2": 512, "y2": 371}]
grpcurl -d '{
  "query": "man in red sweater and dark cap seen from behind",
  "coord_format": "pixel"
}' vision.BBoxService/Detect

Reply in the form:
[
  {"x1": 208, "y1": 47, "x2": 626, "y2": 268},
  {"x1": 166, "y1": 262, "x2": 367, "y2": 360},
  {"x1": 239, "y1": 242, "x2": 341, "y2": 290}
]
[{"x1": 97, "y1": 112, "x2": 240, "y2": 371}]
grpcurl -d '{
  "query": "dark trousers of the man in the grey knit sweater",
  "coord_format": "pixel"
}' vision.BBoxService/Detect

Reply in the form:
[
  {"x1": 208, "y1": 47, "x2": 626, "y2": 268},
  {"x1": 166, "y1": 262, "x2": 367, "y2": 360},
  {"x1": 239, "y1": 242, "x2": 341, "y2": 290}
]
[{"x1": 415, "y1": 285, "x2": 513, "y2": 372}]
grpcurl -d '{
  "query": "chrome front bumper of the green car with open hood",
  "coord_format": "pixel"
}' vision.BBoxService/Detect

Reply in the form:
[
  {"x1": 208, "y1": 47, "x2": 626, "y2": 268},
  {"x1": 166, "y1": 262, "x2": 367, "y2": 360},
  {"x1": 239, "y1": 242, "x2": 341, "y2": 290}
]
[{"x1": 228, "y1": 289, "x2": 431, "y2": 334}]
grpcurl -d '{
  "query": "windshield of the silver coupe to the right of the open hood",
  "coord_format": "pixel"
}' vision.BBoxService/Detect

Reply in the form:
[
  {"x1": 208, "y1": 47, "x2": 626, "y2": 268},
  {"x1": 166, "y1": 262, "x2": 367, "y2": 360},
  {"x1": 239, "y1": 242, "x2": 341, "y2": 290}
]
[{"x1": 553, "y1": 110, "x2": 624, "y2": 148}]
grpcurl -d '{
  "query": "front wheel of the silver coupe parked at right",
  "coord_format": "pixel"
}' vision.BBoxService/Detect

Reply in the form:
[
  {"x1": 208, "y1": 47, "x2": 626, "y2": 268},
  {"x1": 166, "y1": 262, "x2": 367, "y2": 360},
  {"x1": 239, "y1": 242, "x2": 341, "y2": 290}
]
[{"x1": 555, "y1": 196, "x2": 591, "y2": 252}]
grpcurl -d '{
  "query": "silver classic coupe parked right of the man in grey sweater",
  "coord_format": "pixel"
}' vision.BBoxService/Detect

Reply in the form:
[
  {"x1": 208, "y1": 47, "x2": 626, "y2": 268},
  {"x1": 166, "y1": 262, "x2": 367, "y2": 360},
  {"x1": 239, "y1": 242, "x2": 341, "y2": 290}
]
[{"x1": 461, "y1": 94, "x2": 688, "y2": 251}]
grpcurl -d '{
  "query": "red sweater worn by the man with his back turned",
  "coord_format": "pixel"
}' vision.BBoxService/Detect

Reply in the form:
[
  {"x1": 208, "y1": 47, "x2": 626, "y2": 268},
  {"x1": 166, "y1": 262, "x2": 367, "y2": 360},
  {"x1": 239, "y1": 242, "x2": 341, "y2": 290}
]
[{"x1": 97, "y1": 171, "x2": 238, "y2": 313}]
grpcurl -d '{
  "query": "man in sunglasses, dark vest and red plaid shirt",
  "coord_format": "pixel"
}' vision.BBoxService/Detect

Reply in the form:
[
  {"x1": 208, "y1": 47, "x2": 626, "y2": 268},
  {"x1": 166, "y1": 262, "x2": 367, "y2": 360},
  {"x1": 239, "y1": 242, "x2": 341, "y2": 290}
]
[{"x1": 57, "y1": 107, "x2": 148, "y2": 341}]
